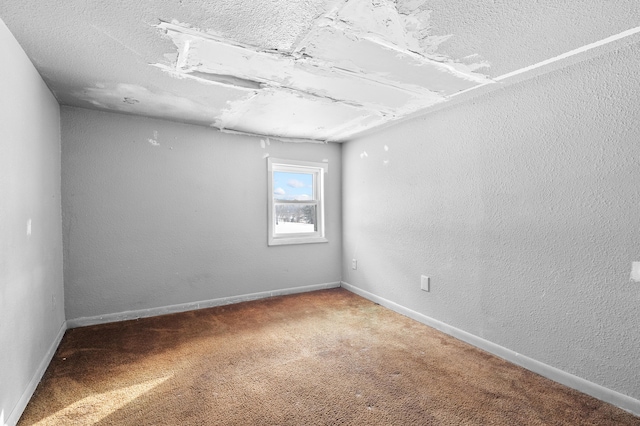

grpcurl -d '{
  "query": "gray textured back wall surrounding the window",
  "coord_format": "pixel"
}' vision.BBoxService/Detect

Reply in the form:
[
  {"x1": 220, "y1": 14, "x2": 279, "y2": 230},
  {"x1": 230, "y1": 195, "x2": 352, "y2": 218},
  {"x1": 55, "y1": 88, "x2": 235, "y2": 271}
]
[{"x1": 62, "y1": 107, "x2": 342, "y2": 319}]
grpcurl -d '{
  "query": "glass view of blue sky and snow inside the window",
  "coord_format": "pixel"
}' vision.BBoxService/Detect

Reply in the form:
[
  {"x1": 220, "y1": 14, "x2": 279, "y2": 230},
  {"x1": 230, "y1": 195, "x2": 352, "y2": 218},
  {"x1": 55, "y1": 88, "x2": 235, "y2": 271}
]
[{"x1": 273, "y1": 172, "x2": 316, "y2": 234}]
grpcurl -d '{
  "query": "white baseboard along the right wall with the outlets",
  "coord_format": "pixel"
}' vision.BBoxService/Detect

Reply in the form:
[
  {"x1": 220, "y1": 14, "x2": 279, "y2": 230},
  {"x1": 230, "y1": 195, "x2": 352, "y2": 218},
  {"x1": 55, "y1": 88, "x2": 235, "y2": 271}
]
[{"x1": 341, "y1": 281, "x2": 640, "y2": 416}]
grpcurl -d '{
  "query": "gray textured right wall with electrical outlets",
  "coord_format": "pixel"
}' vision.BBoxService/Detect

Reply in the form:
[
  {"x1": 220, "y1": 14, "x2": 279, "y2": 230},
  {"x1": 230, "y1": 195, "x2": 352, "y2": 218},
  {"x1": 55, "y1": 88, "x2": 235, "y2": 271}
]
[{"x1": 342, "y1": 45, "x2": 640, "y2": 399}]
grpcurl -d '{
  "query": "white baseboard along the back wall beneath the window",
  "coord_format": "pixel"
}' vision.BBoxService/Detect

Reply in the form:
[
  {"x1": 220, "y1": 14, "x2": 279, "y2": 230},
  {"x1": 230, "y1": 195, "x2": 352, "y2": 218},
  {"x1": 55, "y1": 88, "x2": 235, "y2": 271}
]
[{"x1": 67, "y1": 281, "x2": 341, "y2": 328}]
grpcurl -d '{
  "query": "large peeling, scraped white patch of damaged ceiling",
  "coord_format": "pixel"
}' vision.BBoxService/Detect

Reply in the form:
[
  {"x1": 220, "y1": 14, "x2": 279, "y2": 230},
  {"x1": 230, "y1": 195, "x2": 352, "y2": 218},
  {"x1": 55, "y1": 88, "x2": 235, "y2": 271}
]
[{"x1": 154, "y1": 0, "x2": 491, "y2": 141}]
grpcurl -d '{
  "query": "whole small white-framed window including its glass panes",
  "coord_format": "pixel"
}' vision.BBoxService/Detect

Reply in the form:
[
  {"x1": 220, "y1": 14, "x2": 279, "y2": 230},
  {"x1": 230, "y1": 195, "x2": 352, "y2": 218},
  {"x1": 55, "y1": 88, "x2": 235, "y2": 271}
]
[{"x1": 267, "y1": 157, "x2": 329, "y2": 246}]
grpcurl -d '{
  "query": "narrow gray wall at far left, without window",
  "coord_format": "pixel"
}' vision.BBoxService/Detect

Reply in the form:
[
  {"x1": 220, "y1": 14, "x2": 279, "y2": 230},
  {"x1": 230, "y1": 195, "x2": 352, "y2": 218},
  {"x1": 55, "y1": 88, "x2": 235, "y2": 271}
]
[{"x1": 0, "y1": 21, "x2": 64, "y2": 425}]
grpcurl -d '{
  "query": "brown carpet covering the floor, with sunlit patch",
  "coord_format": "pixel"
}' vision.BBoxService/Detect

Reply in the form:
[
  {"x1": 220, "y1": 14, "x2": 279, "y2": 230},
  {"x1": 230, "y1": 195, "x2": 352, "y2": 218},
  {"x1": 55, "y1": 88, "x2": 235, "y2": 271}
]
[{"x1": 19, "y1": 289, "x2": 640, "y2": 425}]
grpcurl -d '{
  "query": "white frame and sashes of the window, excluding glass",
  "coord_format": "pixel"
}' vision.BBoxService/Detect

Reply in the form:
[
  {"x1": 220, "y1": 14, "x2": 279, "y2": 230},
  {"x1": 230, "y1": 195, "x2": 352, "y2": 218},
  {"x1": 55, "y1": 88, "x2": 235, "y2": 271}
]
[{"x1": 267, "y1": 157, "x2": 329, "y2": 246}]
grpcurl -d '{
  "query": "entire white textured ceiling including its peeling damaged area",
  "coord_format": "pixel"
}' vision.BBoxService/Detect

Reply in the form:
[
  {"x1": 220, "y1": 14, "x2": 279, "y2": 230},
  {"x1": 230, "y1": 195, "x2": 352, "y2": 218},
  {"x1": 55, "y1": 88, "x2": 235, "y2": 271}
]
[{"x1": 0, "y1": 0, "x2": 640, "y2": 141}]
